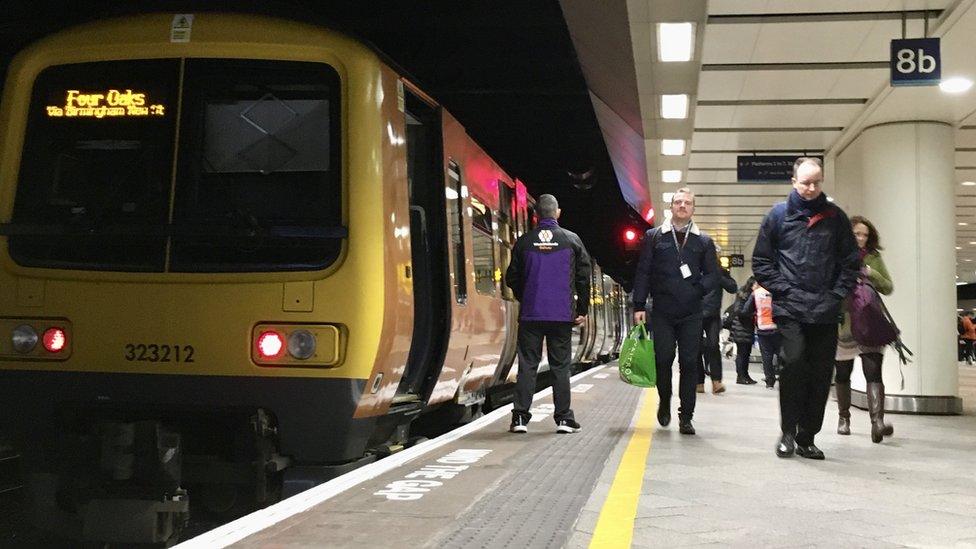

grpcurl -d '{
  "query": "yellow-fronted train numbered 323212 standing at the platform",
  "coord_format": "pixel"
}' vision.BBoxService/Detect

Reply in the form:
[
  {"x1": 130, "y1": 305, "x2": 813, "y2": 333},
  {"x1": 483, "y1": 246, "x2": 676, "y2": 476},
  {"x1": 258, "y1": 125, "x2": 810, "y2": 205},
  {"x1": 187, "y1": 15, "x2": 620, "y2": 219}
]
[{"x1": 0, "y1": 13, "x2": 629, "y2": 544}]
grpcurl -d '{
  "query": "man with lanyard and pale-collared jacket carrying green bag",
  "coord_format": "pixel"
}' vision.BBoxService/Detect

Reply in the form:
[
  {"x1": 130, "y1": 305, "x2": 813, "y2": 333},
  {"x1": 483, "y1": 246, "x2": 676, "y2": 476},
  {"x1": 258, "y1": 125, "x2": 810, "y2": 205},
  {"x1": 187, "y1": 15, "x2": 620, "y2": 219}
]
[{"x1": 634, "y1": 188, "x2": 719, "y2": 435}]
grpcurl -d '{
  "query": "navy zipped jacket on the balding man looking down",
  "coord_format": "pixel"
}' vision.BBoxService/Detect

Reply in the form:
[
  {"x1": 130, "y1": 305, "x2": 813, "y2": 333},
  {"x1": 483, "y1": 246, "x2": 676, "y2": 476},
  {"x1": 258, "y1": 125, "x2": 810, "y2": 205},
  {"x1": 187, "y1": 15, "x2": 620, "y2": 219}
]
[{"x1": 752, "y1": 191, "x2": 861, "y2": 324}]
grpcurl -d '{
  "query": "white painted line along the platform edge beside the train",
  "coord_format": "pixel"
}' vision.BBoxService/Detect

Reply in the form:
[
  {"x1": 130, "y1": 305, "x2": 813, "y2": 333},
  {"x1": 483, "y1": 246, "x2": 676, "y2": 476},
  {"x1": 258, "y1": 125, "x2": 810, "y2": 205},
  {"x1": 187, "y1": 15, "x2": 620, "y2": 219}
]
[{"x1": 175, "y1": 366, "x2": 606, "y2": 549}]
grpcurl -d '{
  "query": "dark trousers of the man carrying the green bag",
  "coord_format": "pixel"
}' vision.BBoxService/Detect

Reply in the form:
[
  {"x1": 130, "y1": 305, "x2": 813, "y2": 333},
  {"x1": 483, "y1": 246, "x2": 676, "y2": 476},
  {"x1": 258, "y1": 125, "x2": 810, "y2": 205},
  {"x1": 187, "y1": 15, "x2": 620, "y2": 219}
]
[{"x1": 652, "y1": 314, "x2": 702, "y2": 419}]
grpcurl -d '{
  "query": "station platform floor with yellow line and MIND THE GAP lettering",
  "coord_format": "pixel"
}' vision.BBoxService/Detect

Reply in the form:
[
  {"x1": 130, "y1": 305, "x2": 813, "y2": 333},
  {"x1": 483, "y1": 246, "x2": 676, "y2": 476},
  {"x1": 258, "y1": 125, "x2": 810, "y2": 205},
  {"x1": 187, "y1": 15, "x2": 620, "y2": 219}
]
[{"x1": 180, "y1": 364, "x2": 976, "y2": 549}]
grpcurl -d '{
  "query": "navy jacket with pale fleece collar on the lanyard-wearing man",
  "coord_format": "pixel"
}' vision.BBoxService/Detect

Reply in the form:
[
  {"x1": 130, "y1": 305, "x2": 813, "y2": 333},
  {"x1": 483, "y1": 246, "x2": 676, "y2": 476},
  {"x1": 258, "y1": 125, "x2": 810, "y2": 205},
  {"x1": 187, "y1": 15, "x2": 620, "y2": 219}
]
[{"x1": 634, "y1": 221, "x2": 719, "y2": 318}]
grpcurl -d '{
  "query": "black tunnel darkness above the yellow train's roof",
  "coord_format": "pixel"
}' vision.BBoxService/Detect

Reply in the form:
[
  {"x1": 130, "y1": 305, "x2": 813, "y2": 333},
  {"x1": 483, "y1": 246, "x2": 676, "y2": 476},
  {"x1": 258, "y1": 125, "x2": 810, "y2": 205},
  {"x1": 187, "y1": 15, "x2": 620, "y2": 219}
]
[{"x1": 0, "y1": 0, "x2": 647, "y2": 286}]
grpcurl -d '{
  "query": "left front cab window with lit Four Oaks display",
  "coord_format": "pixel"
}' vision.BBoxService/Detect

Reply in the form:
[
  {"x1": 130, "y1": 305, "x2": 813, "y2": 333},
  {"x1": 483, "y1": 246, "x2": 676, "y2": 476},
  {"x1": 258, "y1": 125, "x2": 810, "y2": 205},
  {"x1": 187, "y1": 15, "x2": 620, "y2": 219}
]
[{"x1": 9, "y1": 59, "x2": 180, "y2": 271}]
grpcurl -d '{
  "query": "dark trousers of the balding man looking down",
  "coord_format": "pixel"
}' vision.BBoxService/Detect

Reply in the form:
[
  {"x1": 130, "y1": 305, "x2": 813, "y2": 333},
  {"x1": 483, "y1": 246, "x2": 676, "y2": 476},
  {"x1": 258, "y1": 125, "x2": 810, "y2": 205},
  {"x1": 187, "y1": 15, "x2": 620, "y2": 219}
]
[{"x1": 776, "y1": 318, "x2": 837, "y2": 446}]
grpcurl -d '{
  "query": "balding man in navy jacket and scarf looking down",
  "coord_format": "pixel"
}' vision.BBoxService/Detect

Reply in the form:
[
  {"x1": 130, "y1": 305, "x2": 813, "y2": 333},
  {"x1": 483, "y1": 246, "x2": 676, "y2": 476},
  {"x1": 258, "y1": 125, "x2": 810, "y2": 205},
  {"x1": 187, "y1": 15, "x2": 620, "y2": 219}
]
[{"x1": 752, "y1": 157, "x2": 861, "y2": 459}]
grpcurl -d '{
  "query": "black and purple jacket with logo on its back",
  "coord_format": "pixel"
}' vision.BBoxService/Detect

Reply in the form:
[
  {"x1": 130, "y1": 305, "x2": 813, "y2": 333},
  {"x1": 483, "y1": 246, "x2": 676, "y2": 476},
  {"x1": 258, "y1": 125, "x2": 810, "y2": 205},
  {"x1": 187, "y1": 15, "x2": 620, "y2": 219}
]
[{"x1": 505, "y1": 219, "x2": 591, "y2": 322}]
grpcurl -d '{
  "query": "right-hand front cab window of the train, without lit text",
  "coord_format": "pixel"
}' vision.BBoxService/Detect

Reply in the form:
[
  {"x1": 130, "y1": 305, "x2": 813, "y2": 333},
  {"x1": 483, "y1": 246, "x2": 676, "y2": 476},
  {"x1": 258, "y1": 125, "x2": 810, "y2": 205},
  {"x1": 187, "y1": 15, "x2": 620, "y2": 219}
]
[{"x1": 170, "y1": 59, "x2": 343, "y2": 272}]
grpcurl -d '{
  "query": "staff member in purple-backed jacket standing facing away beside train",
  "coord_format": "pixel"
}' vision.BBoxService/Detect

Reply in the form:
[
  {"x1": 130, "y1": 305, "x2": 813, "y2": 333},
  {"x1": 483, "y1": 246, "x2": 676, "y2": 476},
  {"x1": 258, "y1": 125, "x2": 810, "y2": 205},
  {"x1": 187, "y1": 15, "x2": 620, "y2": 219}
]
[{"x1": 505, "y1": 194, "x2": 590, "y2": 433}]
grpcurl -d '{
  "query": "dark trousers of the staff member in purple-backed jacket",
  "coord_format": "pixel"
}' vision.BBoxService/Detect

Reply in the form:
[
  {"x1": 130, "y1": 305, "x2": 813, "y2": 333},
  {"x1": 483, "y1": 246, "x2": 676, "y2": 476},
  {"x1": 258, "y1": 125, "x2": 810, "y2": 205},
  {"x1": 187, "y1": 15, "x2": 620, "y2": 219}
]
[{"x1": 512, "y1": 322, "x2": 574, "y2": 423}]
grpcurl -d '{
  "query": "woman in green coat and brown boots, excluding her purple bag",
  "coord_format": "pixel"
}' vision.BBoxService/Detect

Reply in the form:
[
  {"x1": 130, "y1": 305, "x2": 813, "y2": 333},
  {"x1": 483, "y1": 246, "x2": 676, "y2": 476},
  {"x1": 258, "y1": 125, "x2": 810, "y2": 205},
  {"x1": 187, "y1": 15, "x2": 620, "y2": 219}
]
[{"x1": 834, "y1": 215, "x2": 894, "y2": 442}]
